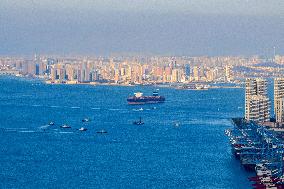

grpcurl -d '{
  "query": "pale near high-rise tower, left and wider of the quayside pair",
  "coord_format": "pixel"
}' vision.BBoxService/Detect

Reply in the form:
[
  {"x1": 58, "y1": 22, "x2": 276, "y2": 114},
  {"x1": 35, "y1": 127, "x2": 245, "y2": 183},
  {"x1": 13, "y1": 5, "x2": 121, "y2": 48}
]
[{"x1": 245, "y1": 78, "x2": 270, "y2": 122}]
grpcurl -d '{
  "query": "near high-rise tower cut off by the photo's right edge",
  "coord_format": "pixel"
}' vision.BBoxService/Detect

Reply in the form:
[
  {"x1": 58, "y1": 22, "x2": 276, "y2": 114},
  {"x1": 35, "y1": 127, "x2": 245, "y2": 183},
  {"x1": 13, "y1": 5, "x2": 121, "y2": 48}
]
[{"x1": 274, "y1": 78, "x2": 284, "y2": 123}]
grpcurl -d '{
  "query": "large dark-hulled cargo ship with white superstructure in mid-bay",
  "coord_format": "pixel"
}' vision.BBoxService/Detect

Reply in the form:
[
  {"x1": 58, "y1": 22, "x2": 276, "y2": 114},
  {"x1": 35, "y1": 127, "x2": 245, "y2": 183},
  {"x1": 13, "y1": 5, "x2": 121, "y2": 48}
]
[{"x1": 127, "y1": 91, "x2": 166, "y2": 105}]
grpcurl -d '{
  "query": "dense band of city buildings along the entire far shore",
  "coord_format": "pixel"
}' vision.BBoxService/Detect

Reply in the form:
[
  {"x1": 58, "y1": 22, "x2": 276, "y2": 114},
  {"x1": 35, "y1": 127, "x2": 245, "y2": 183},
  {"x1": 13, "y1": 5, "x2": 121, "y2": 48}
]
[{"x1": 0, "y1": 55, "x2": 284, "y2": 85}]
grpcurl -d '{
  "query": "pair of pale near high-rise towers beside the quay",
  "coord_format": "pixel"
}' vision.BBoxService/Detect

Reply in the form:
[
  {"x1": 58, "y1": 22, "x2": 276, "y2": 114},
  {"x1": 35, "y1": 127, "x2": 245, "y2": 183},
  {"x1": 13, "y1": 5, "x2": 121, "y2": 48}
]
[{"x1": 245, "y1": 78, "x2": 284, "y2": 126}]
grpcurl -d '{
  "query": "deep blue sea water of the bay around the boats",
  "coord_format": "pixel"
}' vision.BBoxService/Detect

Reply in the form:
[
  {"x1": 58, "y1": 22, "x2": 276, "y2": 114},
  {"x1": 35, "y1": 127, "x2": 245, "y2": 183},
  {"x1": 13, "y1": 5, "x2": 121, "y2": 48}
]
[{"x1": 0, "y1": 77, "x2": 253, "y2": 189}]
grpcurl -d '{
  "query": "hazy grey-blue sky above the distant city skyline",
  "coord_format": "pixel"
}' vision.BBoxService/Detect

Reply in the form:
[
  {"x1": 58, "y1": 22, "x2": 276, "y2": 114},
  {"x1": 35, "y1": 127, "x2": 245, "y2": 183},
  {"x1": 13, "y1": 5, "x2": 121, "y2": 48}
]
[{"x1": 0, "y1": 0, "x2": 284, "y2": 56}]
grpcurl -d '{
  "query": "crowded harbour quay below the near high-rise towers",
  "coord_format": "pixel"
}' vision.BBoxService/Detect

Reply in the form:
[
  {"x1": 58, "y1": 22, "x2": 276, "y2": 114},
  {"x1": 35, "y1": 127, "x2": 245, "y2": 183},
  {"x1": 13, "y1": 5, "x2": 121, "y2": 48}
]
[{"x1": 225, "y1": 118, "x2": 284, "y2": 189}]
